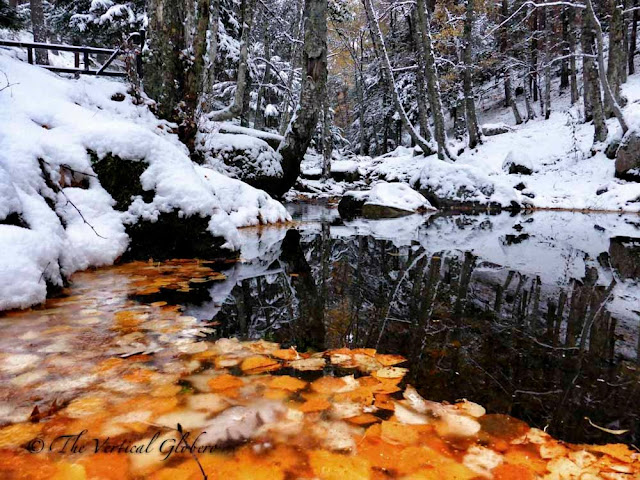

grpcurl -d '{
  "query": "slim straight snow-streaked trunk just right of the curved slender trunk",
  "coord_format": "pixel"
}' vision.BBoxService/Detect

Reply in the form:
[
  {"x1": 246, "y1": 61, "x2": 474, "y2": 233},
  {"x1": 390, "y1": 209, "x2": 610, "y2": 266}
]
[{"x1": 416, "y1": 0, "x2": 455, "y2": 159}]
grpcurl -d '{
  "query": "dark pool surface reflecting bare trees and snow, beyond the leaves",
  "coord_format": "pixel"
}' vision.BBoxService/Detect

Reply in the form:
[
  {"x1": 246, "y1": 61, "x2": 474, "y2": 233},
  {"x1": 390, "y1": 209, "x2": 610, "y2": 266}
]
[{"x1": 182, "y1": 206, "x2": 640, "y2": 443}]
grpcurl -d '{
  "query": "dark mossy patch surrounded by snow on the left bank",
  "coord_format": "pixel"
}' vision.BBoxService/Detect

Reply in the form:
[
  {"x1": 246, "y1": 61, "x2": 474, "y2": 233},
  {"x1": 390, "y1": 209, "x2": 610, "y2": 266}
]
[{"x1": 89, "y1": 151, "x2": 154, "y2": 211}]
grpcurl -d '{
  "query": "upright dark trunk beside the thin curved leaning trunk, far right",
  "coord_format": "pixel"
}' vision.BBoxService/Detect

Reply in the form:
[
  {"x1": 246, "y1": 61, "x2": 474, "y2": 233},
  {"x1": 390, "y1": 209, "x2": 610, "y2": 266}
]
[{"x1": 582, "y1": 12, "x2": 608, "y2": 142}]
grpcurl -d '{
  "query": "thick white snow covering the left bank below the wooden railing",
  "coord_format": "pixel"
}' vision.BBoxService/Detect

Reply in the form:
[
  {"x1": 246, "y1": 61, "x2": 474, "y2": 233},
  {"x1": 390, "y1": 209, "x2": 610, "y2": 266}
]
[{"x1": 0, "y1": 50, "x2": 290, "y2": 310}]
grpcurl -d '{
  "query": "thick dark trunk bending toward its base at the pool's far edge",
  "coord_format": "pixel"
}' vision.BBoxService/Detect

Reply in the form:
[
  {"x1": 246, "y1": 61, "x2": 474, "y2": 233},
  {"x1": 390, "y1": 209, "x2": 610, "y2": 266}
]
[{"x1": 275, "y1": 0, "x2": 327, "y2": 194}]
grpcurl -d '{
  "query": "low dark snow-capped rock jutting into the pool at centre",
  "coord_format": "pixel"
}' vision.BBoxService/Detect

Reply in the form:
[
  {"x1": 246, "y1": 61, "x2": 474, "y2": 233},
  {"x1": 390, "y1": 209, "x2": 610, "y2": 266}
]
[{"x1": 338, "y1": 182, "x2": 435, "y2": 218}]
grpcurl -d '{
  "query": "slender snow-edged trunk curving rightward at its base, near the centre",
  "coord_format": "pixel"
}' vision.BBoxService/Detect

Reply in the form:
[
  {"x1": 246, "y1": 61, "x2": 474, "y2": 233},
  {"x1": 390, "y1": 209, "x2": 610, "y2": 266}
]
[{"x1": 363, "y1": 0, "x2": 433, "y2": 155}]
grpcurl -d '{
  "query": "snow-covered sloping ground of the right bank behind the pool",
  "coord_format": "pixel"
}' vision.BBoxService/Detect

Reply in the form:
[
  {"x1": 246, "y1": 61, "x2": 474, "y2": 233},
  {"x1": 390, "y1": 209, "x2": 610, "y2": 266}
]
[{"x1": 292, "y1": 75, "x2": 640, "y2": 212}]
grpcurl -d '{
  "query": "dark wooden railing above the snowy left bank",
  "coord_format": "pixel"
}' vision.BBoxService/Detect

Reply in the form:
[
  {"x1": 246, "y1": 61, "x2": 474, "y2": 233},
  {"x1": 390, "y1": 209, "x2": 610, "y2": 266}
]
[{"x1": 0, "y1": 32, "x2": 144, "y2": 77}]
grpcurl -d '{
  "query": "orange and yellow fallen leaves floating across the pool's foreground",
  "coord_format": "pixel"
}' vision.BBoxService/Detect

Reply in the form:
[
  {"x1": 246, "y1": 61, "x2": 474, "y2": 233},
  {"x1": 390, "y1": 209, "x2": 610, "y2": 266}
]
[{"x1": 0, "y1": 260, "x2": 640, "y2": 480}]
